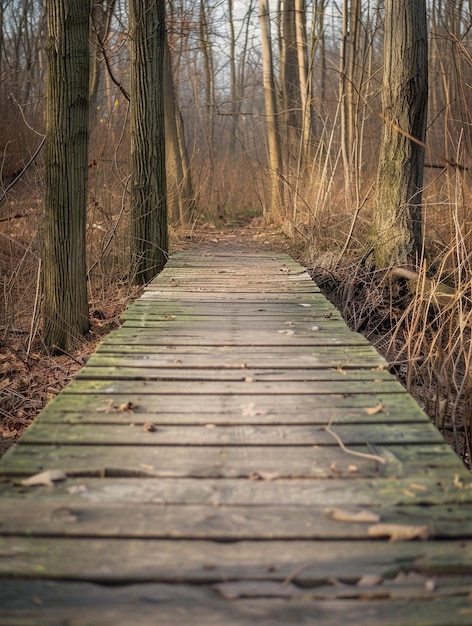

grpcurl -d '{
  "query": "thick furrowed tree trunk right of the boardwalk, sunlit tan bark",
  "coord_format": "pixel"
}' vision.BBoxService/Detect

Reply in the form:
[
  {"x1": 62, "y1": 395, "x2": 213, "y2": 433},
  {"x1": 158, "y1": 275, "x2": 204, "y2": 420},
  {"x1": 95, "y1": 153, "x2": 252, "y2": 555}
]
[{"x1": 374, "y1": 0, "x2": 428, "y2": 268}]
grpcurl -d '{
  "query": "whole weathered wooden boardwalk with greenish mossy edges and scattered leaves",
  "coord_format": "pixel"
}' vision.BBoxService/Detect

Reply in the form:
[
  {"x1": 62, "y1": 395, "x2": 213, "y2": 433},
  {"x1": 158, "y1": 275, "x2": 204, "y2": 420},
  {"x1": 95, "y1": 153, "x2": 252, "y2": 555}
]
[{"x1": 0, "y1": 241, "x2": 472, "y2": 626}]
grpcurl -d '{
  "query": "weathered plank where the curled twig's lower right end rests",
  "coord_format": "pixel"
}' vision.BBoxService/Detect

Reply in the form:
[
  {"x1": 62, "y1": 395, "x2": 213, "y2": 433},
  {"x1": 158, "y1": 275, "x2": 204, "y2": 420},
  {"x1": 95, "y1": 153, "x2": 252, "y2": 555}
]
[{"x1": 0, "y1": 443, "x2": 460, "y2": 478}]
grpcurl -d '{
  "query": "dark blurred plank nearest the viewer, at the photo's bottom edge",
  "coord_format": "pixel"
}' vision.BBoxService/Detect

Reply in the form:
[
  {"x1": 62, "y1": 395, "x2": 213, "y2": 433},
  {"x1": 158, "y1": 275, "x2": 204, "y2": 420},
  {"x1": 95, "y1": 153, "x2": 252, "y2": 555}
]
[{"x1": 0, "y1": 579, "x2": 471, "y2": 626}]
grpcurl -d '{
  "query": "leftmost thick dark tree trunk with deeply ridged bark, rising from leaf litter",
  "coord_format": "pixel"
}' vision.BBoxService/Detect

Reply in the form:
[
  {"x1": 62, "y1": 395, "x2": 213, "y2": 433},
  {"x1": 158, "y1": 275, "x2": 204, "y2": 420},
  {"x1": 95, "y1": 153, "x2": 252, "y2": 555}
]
[{"x1": 42, "y1": 0, "x2": 90, "y2": 352}]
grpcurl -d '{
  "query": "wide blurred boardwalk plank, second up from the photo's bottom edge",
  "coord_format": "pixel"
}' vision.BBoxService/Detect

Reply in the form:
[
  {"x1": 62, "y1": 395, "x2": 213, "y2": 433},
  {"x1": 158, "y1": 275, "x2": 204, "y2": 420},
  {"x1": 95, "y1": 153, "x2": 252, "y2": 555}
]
[{"x1": 0, "y1": 537, "x2": 472, "y2": 586}]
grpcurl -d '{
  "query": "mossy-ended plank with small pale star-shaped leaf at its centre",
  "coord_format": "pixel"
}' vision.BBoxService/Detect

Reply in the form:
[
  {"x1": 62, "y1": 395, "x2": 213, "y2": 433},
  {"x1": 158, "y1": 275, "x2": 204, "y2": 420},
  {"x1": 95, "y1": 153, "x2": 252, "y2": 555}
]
[{"x1": 41, "y1": 386, "x2": 428, "y2": 424}]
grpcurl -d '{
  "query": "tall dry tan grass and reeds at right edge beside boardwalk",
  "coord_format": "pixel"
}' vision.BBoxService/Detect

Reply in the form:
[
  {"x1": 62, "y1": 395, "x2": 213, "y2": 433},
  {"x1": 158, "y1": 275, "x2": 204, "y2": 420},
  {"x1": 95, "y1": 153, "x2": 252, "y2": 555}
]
[{"x1": 389, "y1": 223, "x2": 472, "y2": 465}]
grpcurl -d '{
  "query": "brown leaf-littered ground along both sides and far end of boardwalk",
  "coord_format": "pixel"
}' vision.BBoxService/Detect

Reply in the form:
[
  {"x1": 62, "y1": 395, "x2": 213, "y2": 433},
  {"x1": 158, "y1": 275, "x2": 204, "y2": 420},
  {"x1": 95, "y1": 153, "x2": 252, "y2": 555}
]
[{"x1": 0, "y1": 218, "x2": 470, "y2": 465}]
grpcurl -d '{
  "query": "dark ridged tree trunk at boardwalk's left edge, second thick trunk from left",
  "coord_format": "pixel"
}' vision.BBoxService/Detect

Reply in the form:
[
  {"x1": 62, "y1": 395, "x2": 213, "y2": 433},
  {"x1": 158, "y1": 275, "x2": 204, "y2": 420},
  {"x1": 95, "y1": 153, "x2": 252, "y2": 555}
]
[{"x1": 129, "y1": 0, "x2": 168, "y2": 284}]
